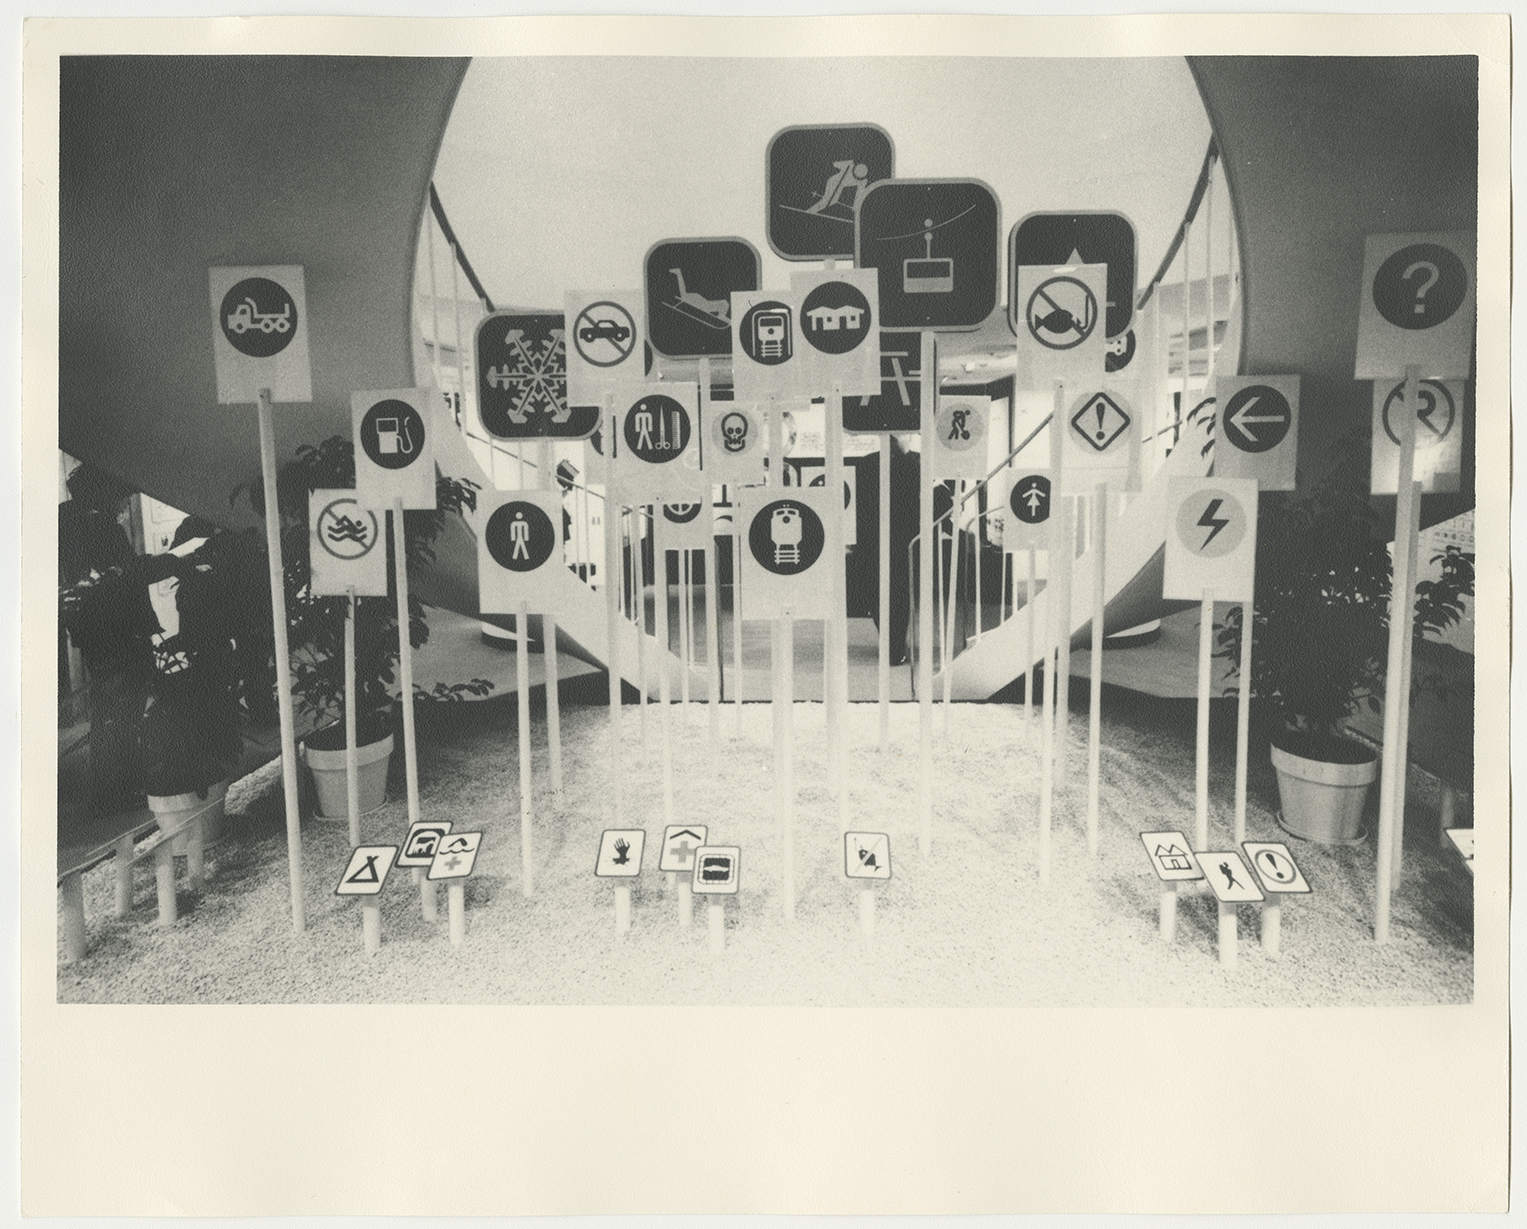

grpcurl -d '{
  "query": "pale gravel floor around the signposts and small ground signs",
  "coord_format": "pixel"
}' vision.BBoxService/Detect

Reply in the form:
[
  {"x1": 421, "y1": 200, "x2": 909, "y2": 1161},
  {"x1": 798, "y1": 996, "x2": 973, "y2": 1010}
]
[{"x1": 58, "y1": 693, "x2": 1474, "y2": 1006}]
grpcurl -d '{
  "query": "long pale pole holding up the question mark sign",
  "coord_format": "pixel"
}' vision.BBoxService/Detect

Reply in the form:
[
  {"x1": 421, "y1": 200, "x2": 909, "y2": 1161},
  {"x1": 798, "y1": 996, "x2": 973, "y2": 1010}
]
[{"x1": 1373, "y1": 366, "x2": 1422, "y2": 944}]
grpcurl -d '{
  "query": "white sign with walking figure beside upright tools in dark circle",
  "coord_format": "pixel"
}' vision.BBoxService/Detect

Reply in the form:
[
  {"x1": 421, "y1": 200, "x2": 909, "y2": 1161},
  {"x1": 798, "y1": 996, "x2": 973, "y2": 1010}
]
[{"x1": 600, "y1": 382, "x2": 710, "y2": 504}]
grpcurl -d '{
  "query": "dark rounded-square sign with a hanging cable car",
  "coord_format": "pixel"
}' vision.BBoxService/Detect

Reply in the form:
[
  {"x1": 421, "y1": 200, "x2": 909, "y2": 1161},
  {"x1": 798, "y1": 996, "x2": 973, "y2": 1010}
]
[{"x1": 854, "y1": 179, "x2": 1001, "y2": 331}]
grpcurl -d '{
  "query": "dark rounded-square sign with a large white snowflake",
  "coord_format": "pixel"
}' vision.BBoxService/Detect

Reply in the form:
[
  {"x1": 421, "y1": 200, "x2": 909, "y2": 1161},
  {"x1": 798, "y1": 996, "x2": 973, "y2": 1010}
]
[{"x1": 476, "y1": 311, "x2": 599, "y2": 440}]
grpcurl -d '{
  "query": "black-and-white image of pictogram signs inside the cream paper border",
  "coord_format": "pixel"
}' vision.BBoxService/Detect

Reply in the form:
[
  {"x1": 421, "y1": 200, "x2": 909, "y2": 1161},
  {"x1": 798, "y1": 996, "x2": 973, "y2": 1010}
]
[{"x1": 26, "y1": 11, "x2": 1509, "y2": 1211}]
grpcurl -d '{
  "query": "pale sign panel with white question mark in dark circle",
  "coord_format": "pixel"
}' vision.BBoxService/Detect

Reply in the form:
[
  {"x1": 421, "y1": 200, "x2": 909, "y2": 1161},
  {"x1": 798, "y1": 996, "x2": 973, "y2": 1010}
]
[{"x1": 1356, "y1": 231, "x2": 1475, "y2": 380}]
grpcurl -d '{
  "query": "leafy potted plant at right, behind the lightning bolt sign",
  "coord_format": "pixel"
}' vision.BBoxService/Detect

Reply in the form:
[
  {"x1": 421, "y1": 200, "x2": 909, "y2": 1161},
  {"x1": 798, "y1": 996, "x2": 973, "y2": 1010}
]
[{"x1": 1215, "y1": 441, "x2": 1474, "y2": 844}]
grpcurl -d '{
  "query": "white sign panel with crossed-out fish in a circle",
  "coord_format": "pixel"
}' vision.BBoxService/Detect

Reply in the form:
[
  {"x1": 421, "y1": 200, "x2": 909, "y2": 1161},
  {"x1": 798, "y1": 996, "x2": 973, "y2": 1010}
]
[{"x1": 1014, "y1": 264, "x2": 1109, "y2": 388}]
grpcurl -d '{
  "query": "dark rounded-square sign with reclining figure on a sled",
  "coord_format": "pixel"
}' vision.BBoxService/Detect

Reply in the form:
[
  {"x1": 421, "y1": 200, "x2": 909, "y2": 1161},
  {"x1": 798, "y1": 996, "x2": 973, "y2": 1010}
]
[{"x1": 643, "y1": 238, "x2": 759, "y2": 359}]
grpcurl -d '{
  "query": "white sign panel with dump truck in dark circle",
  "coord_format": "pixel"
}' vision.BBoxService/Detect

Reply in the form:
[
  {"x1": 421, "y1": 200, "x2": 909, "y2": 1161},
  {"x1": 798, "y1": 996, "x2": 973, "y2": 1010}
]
[{"x1": 208, "y1": 264, "x2": 313, "y2": 406}]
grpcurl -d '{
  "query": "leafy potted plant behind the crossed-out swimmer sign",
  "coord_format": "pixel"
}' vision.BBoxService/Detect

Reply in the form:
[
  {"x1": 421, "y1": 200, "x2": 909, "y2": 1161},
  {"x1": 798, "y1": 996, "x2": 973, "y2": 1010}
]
[{"x1": 235, "y1": 435, "x2": 492, "y2": 820}]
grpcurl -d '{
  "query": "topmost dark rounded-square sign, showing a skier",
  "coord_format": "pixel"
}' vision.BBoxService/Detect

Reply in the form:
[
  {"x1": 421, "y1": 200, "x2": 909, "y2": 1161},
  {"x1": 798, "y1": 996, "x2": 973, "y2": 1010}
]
[{"x1": 765, "y1": 124, "x2": 896, "y2": 261}]
